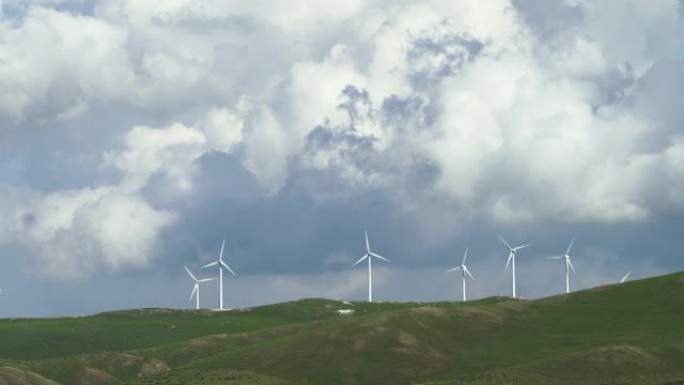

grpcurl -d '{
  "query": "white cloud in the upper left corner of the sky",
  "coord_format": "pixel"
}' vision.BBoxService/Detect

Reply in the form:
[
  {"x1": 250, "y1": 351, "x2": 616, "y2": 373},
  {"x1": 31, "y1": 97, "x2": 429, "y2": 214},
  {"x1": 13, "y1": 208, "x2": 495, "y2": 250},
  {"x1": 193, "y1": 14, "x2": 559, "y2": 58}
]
[{"x1": 0, "y1": 6, "x2": 135, "y2": 120}]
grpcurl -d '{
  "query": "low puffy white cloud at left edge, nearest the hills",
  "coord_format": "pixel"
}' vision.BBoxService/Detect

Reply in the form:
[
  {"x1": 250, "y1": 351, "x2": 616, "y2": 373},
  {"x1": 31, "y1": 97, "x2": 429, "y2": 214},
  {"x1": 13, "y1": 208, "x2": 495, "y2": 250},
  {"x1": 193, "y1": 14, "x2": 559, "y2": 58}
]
[{"x1": 0, "y1": 186, "x2": 176, "y2": 279}]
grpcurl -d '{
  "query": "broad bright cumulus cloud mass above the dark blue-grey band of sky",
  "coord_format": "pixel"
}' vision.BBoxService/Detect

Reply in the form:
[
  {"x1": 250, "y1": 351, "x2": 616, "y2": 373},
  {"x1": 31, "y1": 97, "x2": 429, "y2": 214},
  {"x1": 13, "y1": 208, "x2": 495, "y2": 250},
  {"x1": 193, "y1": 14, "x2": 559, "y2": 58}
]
[{"x1": 0, "y1": 0, "x2": 684, "y2": 284}]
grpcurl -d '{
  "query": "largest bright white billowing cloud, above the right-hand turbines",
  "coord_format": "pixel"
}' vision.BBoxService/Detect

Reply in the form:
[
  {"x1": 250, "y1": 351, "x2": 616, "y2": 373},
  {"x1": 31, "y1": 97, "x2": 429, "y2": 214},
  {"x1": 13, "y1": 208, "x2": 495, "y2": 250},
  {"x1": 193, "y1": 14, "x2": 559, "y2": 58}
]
[{"x1": 280, "y1": 3, "x2": 684, "y2": 222}]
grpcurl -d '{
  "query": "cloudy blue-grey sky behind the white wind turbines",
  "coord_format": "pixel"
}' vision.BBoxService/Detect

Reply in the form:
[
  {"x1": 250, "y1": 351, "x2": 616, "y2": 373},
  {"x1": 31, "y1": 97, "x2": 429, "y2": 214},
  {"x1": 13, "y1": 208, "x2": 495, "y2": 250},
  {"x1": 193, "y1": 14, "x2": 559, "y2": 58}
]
[{"x1": 0, "y1": 0, "x2": 684, "y2": 318}]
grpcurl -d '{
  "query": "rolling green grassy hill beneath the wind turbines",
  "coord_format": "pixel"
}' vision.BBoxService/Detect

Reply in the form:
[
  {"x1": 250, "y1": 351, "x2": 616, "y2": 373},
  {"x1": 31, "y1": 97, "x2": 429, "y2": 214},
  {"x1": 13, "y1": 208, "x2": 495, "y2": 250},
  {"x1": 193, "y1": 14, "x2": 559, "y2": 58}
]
[{"x1": 0, "y1": 273, "x2": 684, "y2": 385}]
